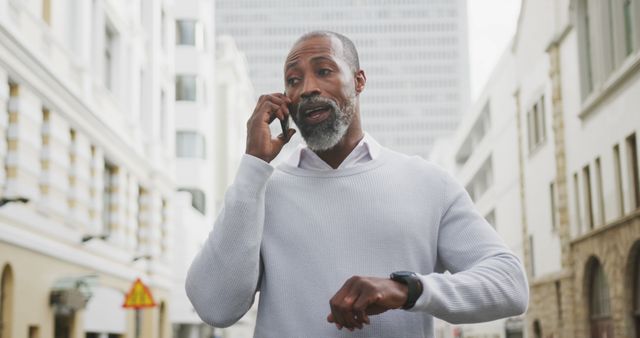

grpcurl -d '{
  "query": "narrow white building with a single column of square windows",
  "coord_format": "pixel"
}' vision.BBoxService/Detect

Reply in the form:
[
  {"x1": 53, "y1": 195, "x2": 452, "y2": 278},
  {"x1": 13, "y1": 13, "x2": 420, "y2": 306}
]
[{"x1": 171, "y1": 0, "x2": 220, "y2": 338}]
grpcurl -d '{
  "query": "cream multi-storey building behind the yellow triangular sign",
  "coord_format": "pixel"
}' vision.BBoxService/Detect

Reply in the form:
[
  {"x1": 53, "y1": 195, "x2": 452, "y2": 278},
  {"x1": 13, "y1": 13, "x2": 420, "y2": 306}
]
[{"x1": 0, "y1": 0, "x2": 174, "y2": 338}]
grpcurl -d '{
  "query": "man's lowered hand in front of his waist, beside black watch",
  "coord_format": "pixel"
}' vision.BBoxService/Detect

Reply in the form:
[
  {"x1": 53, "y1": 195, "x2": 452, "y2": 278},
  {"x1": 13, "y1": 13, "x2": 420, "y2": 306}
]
[{"x1": 327, "y1": 276, "x2": 408, "y2": 331}]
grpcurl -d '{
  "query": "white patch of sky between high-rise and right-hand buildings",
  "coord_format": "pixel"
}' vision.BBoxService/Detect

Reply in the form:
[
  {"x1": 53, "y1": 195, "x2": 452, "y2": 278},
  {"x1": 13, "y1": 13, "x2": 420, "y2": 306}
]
[{"x1": 467, "y1": 0, "x2": 521, "y2": 102}]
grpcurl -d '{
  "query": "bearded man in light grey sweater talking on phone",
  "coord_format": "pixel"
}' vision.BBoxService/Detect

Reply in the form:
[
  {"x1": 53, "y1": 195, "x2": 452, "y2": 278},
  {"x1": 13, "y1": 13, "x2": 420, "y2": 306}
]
[{"x1": 186, "y1": 32, "x2": 529, "y2": 337}]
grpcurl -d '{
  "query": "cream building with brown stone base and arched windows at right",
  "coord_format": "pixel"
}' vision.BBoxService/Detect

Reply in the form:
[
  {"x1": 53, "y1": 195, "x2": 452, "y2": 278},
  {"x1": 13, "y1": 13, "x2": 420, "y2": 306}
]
[{"x1": 438, "y1": 0, "x2": 640, "y2": 338}]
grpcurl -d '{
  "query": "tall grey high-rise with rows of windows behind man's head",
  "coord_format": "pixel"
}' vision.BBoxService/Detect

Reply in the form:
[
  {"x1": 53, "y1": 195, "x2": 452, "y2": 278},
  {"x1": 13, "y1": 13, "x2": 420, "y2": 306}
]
[{"x1": 216, "y1": 0, "x2": 469, "y2": 157}]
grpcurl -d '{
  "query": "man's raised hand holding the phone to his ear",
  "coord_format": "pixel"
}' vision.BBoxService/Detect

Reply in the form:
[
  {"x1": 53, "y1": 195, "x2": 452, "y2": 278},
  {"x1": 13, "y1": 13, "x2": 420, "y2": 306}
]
[{"x1": 246, "y1": 93, "x2": 296, "y2": 162}]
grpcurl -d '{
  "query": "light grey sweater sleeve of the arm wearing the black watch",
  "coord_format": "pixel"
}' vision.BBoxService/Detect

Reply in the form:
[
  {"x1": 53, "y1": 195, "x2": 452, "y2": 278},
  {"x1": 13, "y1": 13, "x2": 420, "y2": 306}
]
[{"x1": 412, "y1": 175, "x2": 529, "y2": 324}]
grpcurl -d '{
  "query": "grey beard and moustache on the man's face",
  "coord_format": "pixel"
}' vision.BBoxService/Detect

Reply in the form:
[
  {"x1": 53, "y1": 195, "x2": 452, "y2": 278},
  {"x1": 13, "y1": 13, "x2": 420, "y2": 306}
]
[{"x1": 292, "y1": 95, "x2": 355, "y2": 151}]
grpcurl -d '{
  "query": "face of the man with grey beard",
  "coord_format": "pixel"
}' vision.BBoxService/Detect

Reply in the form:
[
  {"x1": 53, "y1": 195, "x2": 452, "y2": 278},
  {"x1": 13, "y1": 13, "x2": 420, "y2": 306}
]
[{"x1": 285, "y1": 37, "x2": 357, "y2": 151}]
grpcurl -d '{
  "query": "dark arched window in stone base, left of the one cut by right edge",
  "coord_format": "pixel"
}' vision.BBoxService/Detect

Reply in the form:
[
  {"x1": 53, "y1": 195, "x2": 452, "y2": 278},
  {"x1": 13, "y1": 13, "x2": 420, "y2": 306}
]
[{"x1": 588, "y1": 259, "x2": 615, "y2": 338}]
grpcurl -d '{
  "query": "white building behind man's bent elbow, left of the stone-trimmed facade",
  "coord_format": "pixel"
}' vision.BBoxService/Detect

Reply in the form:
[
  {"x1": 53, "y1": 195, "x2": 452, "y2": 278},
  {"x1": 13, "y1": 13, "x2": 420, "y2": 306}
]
[{"x1": 431, "y1": 50, "x2": 523, "y2": 338}]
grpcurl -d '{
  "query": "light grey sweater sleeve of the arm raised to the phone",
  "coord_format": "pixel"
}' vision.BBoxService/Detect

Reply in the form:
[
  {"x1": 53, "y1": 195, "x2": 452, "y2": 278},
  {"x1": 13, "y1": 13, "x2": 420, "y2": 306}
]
[{"x1": 185, "y1": 155, "x2": 274, "y2": 327}]
